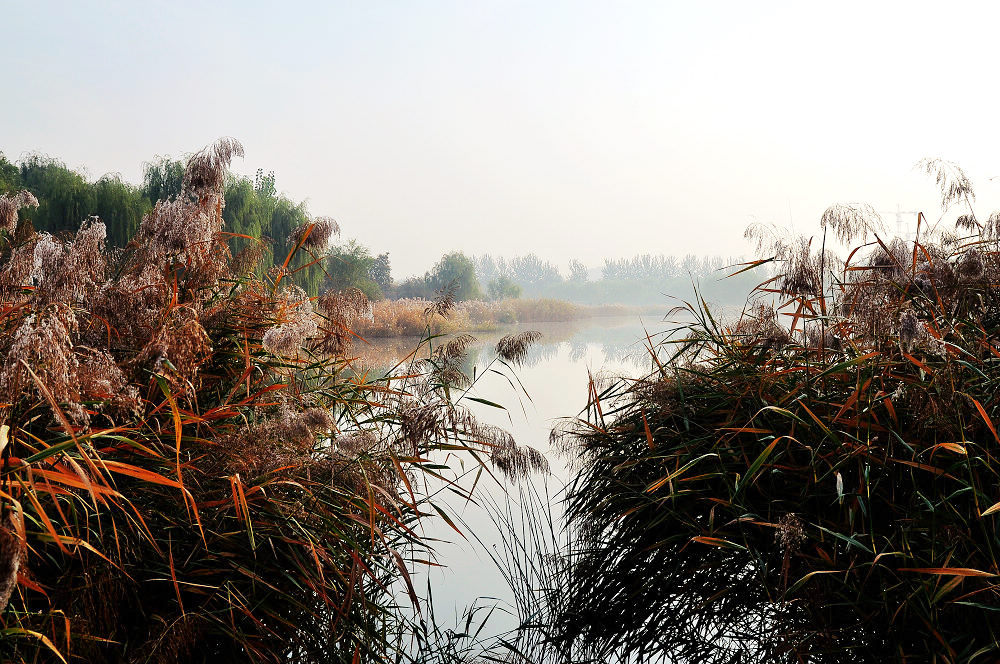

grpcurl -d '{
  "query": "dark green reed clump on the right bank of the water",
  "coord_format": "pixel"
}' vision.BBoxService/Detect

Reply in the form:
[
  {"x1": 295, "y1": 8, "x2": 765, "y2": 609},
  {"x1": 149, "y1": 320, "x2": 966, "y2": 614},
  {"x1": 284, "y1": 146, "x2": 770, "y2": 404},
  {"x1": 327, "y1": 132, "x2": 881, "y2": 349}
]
[{"x1": 533, "y1": 162, "x2": 1000, "y2": 663}]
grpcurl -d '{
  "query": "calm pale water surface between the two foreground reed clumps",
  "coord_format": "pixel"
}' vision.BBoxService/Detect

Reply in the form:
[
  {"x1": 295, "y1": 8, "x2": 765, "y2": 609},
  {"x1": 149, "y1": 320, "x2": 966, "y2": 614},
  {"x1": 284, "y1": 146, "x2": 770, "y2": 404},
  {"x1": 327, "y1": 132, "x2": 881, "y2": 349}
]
[{"x1": 356, "y1": 315, "x2": 673, "y2": 633}]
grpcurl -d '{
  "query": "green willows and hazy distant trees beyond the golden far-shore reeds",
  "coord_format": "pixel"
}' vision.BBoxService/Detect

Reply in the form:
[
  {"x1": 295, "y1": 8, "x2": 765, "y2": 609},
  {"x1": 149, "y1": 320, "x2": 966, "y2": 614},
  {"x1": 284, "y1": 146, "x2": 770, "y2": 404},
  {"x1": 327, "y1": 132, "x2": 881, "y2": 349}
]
[{"x1": 0, "y1": 148, "x2": 756, "y2": 304}]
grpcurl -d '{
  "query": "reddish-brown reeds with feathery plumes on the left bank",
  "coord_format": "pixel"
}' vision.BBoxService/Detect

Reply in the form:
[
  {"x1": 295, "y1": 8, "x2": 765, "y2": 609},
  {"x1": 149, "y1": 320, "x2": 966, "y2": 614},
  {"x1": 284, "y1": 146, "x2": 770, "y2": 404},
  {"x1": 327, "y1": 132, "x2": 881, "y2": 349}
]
[{"x1": 0, "y1": 140, "x2": 535, "y2": 662}]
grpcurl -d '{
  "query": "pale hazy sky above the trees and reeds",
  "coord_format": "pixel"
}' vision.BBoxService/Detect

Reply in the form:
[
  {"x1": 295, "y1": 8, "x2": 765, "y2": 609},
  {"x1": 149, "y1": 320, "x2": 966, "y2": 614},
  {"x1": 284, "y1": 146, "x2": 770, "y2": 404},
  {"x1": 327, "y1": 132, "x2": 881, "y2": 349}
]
[{"x1": 0, "y1": 0, "x2": 1000, "y2": 276}]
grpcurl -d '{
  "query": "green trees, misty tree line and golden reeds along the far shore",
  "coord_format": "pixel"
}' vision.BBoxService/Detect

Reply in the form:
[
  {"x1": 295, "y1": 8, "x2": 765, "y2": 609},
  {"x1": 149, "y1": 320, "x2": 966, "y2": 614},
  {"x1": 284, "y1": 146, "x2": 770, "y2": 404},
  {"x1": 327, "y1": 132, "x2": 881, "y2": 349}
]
[{"x1": 0, "y1": 153, "x2": 759, "y2": 336}]
